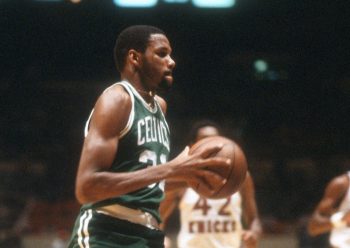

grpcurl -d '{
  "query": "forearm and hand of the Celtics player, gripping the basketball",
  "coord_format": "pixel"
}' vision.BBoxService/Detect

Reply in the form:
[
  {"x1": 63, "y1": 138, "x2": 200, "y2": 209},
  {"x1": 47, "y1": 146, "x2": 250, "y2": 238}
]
[{"x1": 76, "y1": 146, "x2": 230, "y2": 204}]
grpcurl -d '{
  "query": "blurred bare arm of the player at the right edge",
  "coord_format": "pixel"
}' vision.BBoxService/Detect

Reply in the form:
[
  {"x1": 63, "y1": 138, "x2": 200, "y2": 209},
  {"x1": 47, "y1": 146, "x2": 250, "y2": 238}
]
[{"x1": 308, "y1": 175, "x2": 350, "y2": 236}]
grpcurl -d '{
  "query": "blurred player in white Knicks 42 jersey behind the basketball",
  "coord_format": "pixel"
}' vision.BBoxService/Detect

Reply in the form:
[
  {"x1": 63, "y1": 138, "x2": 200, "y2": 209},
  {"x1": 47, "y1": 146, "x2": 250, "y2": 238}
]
[{"x1": 160, "y1": 120, "x2": 261, "y2": 248}]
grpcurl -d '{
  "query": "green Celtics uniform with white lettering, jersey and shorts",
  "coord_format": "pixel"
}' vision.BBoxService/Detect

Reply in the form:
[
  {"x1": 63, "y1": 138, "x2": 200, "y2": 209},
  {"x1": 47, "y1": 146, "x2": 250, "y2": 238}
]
[{"x1": 69, "y1": 81, "x2": 170, "y2": 248}]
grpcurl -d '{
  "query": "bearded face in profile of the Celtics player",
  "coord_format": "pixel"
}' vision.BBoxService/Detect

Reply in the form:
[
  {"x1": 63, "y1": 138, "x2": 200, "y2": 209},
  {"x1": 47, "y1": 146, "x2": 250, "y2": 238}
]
[{"x1": 140, "y1": 34, "x2": 175, "y2": 90}]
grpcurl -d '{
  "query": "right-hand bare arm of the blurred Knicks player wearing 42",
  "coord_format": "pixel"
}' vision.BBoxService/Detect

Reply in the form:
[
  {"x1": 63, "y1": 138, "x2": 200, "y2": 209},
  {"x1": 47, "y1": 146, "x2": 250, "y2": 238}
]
[{"x1": 240, "y1": 172, "x2": 262, "y2": 248}]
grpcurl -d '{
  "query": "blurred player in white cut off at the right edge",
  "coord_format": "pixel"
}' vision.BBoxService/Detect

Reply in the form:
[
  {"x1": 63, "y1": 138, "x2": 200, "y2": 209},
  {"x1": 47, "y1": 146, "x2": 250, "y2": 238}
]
[{"x1": 308, "y1": 171, "x2": 350, "y2": 248}]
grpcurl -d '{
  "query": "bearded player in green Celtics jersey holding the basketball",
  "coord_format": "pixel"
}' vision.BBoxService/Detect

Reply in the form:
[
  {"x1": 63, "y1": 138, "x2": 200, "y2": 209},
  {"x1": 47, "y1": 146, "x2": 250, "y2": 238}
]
[{"x1": 69, "y1": 25, "x2": 230, "y2": 248}]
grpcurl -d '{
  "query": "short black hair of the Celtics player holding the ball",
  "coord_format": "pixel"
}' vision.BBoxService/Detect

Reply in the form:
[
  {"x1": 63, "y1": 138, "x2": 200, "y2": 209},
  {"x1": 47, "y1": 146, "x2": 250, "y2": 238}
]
[{"x1": 114, "y1": 25, "x2": 165, "y2": 71}]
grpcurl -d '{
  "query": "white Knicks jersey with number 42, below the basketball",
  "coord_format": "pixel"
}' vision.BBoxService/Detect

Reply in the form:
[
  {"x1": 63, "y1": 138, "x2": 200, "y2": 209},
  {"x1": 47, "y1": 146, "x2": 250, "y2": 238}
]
[{"x1": 177, "y1": 188, "x2": 242, "y2": 248}]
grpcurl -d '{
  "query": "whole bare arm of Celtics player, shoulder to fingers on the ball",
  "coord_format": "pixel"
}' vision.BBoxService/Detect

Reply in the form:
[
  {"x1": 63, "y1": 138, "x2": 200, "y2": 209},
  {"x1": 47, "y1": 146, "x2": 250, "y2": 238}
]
[{"x1": 76, "y1": 86, "x2": 228, "y2": 203}]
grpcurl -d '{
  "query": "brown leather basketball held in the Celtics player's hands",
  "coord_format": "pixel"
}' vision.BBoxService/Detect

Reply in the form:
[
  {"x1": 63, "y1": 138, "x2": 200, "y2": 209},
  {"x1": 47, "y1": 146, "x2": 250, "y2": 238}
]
[{"x1": 190, "y1": 136, "x2": 248, "y2": 199}]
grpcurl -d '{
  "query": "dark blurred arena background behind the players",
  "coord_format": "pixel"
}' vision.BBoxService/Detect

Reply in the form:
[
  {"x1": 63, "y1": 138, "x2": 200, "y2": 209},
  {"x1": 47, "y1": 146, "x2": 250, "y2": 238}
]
[{"x1": 0, "y1": 0, "x2": 350, "y2": 220}]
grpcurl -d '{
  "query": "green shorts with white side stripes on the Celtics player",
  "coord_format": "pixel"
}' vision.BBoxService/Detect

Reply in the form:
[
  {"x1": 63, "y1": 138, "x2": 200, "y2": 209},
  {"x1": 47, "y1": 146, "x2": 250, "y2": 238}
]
[{"x1": 68, "y1": 209, "x2": 164, "y2": 248}]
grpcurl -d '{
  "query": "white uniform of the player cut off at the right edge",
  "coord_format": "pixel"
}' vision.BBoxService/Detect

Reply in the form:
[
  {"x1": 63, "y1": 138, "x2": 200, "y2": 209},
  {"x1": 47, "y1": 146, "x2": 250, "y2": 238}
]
[{"x1": 330, "y1": 172, "x2": 350, "y2": 248}]
